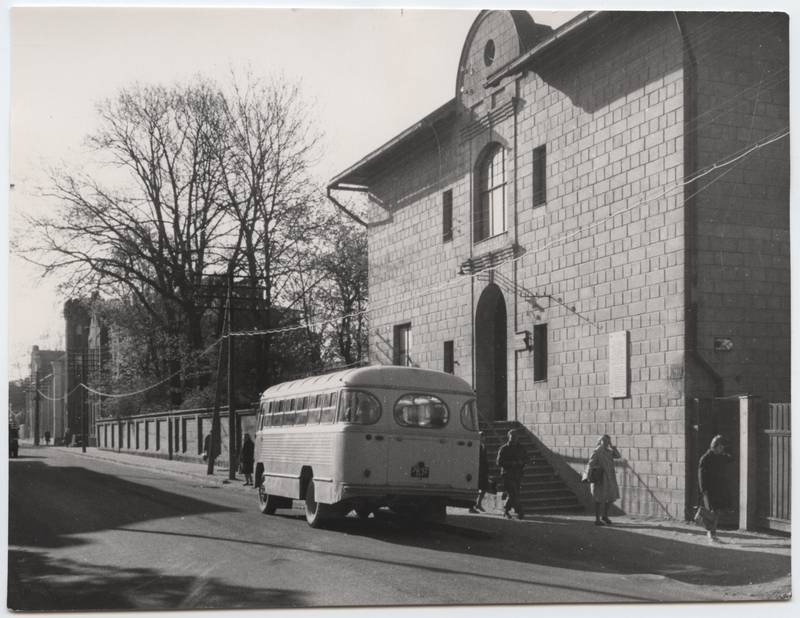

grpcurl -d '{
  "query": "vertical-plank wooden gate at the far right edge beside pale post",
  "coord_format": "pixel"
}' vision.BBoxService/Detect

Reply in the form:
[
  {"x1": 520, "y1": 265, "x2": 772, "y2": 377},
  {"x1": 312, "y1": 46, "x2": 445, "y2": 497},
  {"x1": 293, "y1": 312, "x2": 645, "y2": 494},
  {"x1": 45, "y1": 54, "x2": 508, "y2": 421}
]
[{"x1": 756, "y1": 403, "x2": 792, "y2": 532}]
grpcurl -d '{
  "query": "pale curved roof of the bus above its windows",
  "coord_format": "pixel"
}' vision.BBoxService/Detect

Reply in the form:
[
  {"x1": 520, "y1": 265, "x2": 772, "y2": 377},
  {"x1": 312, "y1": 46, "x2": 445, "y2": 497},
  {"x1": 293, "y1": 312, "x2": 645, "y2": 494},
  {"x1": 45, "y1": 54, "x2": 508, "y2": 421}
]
[{"x1": 261, "y1": 365, "x2": 474, "y2": 397}]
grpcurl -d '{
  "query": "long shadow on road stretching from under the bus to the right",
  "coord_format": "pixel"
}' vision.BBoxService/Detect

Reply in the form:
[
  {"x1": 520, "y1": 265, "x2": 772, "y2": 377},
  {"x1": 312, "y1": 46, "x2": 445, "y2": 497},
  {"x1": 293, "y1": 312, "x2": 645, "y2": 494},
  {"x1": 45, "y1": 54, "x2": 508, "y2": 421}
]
[{"x1": 316, "y1": 508, "x2": 791, "y2": 586}]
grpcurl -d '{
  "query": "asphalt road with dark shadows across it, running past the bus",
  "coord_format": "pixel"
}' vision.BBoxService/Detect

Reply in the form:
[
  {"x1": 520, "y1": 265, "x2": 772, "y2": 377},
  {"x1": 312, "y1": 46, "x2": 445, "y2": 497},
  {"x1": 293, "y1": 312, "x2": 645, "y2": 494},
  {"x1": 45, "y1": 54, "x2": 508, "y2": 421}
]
[{"x1": 8, "y1": 448, "x2": 789, "y2": 611}]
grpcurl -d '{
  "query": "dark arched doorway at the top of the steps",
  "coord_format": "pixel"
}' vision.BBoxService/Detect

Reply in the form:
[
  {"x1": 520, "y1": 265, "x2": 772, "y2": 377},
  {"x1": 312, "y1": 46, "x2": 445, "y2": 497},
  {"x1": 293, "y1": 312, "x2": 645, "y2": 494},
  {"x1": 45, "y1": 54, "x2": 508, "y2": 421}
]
[{"x1": 475, "y1": 283, "x2": 508, "y2": 421}]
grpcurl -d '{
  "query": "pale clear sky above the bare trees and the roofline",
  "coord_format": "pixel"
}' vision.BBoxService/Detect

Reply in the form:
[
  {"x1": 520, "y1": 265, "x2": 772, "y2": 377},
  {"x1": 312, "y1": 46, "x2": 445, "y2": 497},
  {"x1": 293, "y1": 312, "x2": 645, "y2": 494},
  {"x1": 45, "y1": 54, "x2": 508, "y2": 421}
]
[{"x1": 4, "y1": 3, "x2": 588, "y2": 379}]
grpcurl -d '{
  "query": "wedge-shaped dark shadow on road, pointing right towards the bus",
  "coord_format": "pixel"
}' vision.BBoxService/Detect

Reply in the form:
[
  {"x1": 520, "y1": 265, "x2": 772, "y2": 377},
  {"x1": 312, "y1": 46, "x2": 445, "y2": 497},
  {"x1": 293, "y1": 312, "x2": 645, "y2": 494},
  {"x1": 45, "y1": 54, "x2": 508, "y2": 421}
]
[{"x1": 8, "y1": 460, "x2": 237, "y2": 548}]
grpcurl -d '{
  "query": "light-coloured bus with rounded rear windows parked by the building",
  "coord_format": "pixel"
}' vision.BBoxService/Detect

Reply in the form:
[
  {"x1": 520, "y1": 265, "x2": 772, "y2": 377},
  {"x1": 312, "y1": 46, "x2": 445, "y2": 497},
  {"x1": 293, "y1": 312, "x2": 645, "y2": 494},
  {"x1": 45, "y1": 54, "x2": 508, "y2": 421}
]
[{"x1": 254, "y1": 366, "x2": 480, "y2": 528}]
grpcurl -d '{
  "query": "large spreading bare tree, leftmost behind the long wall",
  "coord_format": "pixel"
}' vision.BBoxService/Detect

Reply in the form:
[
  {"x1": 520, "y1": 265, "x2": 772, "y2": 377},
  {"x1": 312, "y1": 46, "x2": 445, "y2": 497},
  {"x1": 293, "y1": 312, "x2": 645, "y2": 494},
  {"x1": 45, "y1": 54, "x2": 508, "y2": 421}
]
[{"x1": 22, "y1": 81, "x2": 231, "y2": 402}]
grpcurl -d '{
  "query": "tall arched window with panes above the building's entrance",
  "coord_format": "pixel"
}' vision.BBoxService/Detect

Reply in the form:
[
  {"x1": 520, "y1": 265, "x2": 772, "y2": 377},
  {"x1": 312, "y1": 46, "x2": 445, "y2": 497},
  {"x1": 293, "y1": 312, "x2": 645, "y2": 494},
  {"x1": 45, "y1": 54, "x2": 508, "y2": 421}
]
[{"x1": 474, "y1": 144, "x2": 506, "y2": 241}]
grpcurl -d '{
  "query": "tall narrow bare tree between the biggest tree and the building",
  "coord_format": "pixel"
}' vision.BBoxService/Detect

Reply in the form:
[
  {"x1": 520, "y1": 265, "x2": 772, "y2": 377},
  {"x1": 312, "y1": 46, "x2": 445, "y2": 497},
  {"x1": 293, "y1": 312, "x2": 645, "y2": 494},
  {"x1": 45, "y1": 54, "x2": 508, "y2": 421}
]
[{"x1": 219, "y1": 76, "x2": 326, "y2": 384}]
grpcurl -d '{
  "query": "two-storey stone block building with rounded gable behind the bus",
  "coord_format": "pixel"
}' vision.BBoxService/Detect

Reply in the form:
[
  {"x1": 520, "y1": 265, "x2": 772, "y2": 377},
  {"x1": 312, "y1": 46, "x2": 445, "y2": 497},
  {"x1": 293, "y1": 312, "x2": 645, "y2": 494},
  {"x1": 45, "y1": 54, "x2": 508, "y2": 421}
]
[{"x1": 329, "y1": 11, "x2": 790, "y2": 517}]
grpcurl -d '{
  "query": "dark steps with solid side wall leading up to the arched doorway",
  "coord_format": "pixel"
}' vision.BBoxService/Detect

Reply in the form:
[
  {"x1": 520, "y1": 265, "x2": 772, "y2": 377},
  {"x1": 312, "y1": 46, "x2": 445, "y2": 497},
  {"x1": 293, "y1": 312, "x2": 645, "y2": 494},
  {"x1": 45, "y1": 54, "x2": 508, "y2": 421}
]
[{"x1": 481, "y1": 421, "x2": 585, "y2": 515}]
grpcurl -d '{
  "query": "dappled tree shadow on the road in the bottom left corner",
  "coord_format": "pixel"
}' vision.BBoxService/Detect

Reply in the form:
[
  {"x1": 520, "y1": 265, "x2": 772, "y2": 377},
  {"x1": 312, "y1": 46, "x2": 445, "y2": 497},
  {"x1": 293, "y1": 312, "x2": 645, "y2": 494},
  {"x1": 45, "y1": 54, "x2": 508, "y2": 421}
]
[{"x1": 8, "y1": 550, "x2": 307, "y2": 611}]
